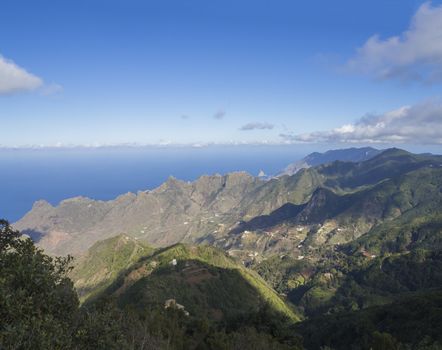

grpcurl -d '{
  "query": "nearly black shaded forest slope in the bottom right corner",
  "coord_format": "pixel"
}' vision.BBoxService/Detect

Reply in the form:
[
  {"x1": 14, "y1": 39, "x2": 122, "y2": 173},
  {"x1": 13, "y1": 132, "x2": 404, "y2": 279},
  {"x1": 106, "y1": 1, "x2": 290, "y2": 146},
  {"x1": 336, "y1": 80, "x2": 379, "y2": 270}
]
[{"x1": 297, "y1": 291, "x2": 442, "y2": 349}]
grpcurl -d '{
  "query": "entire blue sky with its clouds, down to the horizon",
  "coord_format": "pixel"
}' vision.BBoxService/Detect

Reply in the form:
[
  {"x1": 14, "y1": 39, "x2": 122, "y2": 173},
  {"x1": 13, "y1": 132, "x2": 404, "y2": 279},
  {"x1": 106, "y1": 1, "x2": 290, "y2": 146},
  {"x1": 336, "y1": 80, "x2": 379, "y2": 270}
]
[{"x1": 0, "y1": 0, "x2": 442, "y2": 147}]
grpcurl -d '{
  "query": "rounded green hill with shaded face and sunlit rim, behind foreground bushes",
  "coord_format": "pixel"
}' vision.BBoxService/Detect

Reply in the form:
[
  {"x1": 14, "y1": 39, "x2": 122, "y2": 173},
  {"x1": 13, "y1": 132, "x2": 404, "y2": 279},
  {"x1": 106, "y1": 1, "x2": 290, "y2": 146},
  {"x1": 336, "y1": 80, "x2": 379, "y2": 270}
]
[{"x1": 89, "y1": 244, "x2": 299, "y2": 321}]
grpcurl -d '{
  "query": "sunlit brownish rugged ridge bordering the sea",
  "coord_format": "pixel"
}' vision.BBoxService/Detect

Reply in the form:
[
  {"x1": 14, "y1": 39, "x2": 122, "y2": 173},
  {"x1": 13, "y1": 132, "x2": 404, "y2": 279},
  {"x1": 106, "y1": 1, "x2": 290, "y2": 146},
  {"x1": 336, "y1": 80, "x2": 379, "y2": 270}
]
[{"x1": 14, "y1": 171, "x2": 320, "y2": 255}]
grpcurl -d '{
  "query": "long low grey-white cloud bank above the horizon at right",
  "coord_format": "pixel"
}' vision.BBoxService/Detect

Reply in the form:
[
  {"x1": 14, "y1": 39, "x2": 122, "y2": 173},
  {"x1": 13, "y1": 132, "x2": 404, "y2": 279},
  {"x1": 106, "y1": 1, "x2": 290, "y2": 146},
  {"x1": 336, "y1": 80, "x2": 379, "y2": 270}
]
[{"x1": 280, "y1": 101, "x2": 442, "y2": 144}]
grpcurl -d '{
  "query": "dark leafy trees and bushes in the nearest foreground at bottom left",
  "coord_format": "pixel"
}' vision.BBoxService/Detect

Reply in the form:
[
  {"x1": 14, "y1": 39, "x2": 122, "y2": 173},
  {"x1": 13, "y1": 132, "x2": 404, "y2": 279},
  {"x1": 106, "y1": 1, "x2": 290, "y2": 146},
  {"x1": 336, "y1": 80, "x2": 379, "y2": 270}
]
[{"x1": 0, "y1": 220, "x2": 300, "y2": 350}]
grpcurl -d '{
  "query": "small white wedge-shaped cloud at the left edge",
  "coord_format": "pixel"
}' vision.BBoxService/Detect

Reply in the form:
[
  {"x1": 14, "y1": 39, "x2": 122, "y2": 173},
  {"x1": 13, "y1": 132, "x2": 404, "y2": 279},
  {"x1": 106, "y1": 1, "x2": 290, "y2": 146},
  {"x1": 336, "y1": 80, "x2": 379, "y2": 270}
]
[{"x1": 0, "y1": 56, "x2": 43, "y2": 95}]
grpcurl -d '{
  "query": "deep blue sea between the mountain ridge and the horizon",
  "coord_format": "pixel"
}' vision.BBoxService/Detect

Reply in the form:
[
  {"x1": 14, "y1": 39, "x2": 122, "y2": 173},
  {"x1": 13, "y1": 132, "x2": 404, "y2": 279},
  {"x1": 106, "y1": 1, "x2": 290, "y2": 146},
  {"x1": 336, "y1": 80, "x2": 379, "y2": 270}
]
[{"x1": 0, "y1": 146, "x2": 317, "y2": 222}]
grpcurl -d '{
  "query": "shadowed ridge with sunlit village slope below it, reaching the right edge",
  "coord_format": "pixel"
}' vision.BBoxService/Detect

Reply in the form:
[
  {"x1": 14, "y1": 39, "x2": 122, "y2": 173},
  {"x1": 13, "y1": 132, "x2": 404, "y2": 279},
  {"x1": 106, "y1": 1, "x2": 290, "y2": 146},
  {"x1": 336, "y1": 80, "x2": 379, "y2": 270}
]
[{"x1": 216, "y1": 167, "x2": 442, "y2": 261}]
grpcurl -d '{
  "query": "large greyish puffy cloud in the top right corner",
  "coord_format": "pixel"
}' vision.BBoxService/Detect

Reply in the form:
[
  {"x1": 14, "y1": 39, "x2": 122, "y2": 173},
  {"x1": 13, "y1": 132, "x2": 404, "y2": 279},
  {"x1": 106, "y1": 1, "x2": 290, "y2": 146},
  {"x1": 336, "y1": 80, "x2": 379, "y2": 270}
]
[{"x1": 347, "y1": 2, "x2": 442, "y2": 83}]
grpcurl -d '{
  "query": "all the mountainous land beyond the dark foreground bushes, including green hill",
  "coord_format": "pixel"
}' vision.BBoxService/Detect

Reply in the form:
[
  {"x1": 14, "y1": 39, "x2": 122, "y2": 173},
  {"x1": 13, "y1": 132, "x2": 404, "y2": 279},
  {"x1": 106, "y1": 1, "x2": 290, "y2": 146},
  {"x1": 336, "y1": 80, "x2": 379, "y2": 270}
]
[{"x1": 8, "y1": 148, "x2": 442, "y2": 349}]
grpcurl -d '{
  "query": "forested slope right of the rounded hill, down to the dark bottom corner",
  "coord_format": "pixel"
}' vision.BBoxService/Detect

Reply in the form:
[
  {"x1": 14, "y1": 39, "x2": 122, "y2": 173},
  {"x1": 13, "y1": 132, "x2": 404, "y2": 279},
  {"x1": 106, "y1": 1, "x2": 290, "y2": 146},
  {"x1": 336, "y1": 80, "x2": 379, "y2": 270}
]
[{"x1": 252, "y1": 245, "x2": 442, "y2": 349}]
